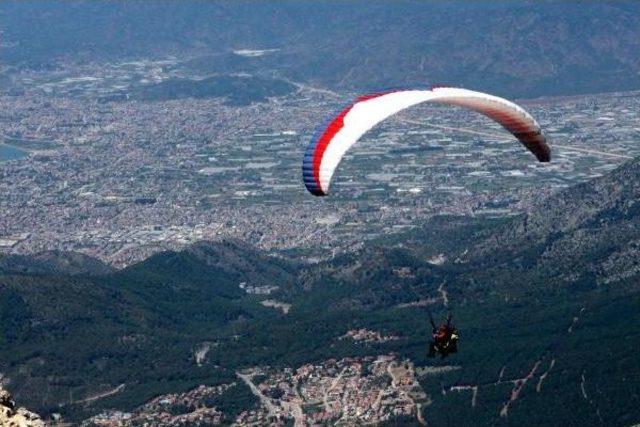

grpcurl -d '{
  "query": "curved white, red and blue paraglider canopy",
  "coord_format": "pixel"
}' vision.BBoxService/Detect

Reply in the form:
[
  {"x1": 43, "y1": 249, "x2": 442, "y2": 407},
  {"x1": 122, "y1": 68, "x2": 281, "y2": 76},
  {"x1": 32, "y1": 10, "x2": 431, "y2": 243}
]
[{"x1": 302, "y1": 87, "x2": 551, "y2": 196}]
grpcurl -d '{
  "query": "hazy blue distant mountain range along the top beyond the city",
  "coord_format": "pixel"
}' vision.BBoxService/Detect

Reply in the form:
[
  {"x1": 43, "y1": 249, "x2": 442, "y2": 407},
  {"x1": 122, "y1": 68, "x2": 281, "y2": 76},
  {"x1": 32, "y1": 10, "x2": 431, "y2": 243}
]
[{"x1": 0, "y1": 0, "x2": 640, "y2": 97}]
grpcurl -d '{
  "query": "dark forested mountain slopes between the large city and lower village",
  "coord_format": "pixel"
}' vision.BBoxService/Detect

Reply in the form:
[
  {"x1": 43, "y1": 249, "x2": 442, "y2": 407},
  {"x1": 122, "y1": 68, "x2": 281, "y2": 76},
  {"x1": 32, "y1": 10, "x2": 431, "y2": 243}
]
[{"x1": 0, "y1": 156, "x2": 640, "y2": 426}]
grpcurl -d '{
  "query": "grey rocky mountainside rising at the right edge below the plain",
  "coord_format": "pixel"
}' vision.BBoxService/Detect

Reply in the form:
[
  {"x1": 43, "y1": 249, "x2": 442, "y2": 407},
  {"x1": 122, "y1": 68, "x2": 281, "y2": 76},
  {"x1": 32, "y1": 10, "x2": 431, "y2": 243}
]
[{"x1": 472, "y1": 160, "x2": 640, "y2": 285}]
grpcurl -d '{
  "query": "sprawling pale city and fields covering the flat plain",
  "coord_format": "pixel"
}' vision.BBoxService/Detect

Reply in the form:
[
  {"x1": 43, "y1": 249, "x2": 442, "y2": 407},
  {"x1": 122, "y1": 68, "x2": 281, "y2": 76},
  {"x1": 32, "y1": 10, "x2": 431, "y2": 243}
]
[{"x1": 0, "y1": 56, "x2": 640, "y2": 267}]
